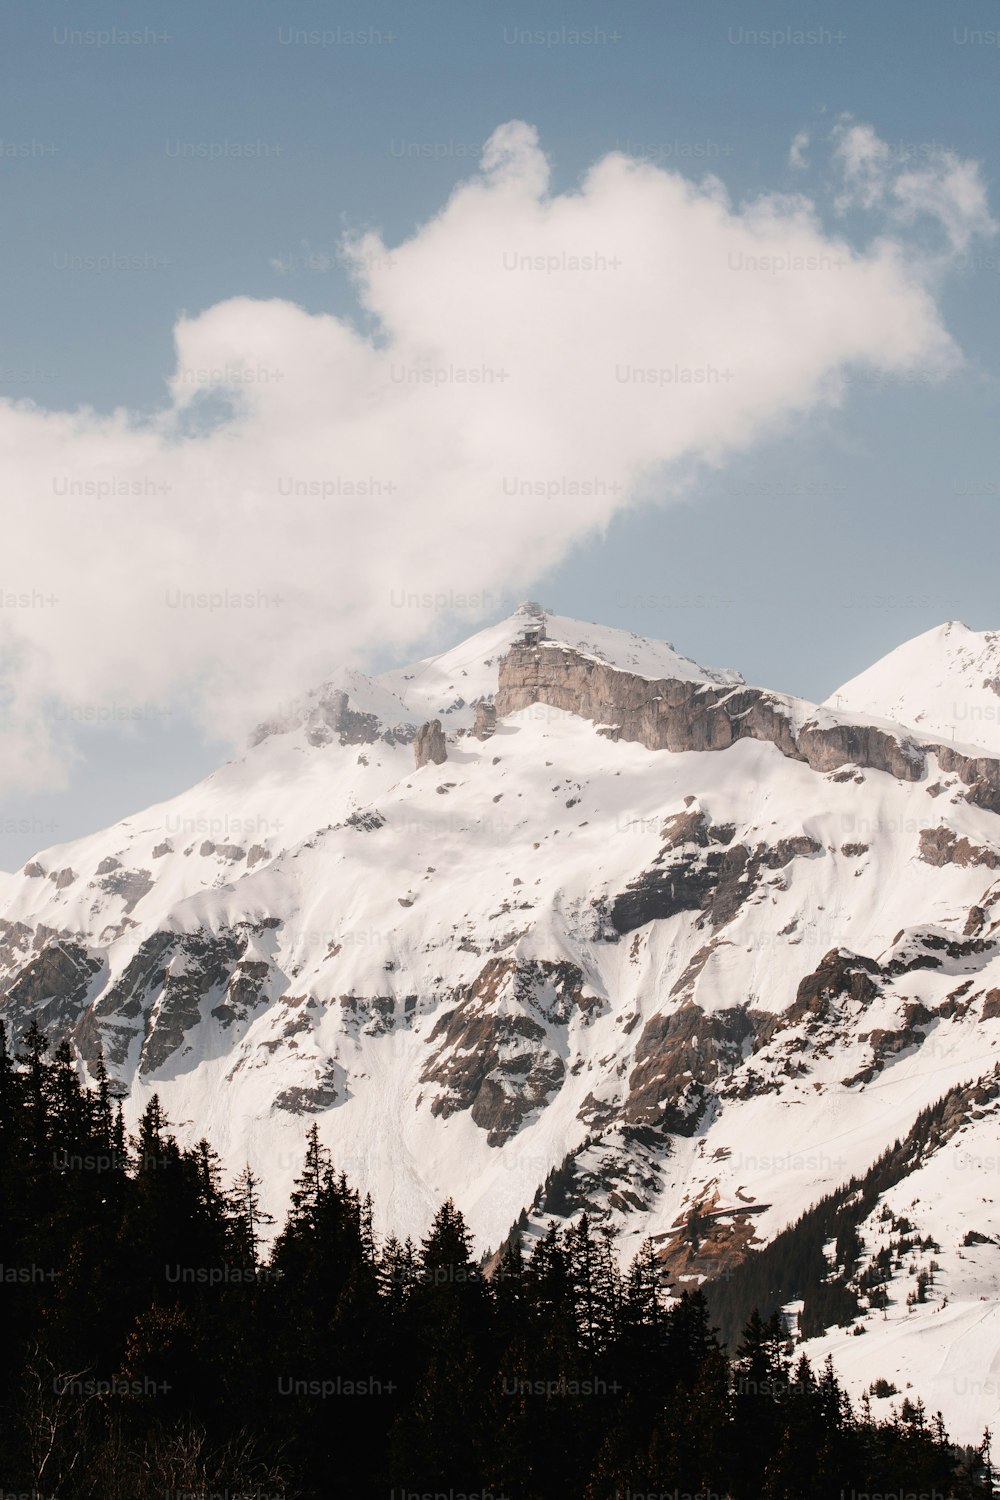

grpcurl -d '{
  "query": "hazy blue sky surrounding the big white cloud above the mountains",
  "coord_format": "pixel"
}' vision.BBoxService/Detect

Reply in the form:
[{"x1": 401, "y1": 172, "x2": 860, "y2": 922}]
[{"x1": 0, "y1": 0, "x2": 1000, "y2": 869}]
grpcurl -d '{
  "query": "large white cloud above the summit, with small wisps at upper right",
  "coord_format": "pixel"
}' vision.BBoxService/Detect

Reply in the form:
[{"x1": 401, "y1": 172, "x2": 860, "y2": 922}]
[{"x1": 0, "y1": 122, "x2": 985, "y2": 783}]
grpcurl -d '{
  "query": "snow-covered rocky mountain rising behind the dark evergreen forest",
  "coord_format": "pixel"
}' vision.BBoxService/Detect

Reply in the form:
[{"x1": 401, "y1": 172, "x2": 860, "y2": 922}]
[{"x1": 0, "y1": 605, "x2": 1000, "y2": 1440}]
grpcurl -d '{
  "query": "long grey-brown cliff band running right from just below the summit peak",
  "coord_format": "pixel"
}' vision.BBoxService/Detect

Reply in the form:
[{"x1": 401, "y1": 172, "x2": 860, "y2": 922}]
[{"x1": 496, "y1": 642, "x2": 929, "y2": 786}]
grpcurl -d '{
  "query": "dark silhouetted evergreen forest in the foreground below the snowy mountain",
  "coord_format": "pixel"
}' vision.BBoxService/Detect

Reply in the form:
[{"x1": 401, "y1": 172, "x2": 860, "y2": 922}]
[{"x1": 0, "y1": 1026, "x2": 991, "y2": 1500}]
